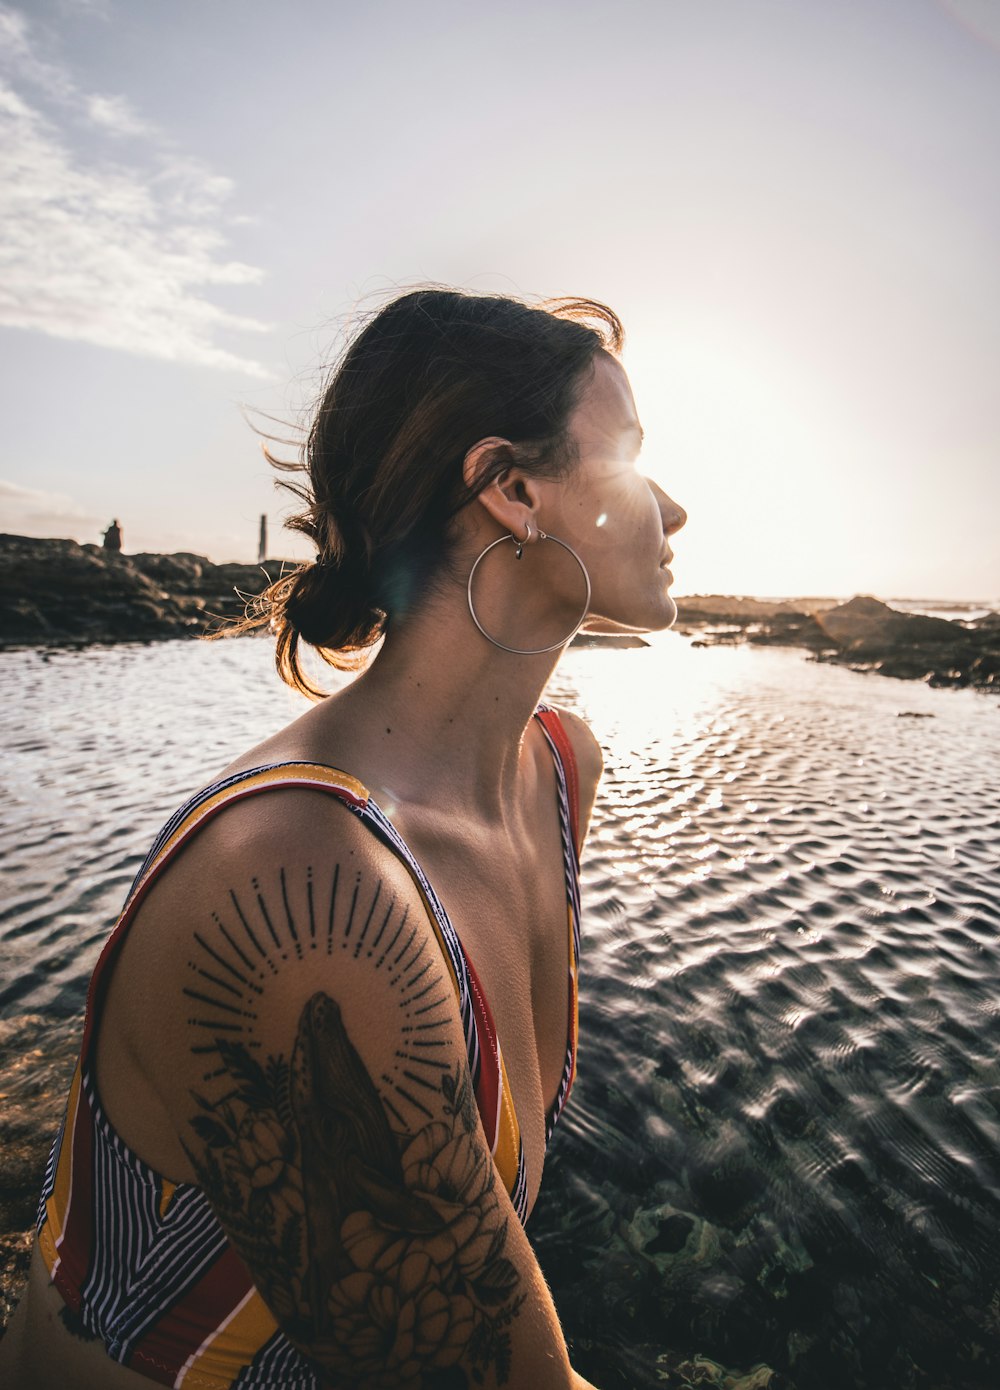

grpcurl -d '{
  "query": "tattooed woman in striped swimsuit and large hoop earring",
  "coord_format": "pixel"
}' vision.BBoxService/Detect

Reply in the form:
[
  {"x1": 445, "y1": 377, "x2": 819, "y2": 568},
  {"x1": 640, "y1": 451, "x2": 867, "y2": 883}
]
[{"x1": 3, "y1": 289, "x2": 684, "y2": 1390}]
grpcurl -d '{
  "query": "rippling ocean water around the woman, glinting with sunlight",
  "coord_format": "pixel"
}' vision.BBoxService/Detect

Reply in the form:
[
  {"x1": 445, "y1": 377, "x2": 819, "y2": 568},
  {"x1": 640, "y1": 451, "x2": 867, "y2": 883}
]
[{"x1": 0, "y1": 634, "x2": 1000, "y2": 1390}]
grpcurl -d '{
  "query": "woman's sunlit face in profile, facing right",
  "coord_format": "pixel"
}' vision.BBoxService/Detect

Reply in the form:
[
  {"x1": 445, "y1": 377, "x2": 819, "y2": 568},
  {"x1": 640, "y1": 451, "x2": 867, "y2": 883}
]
[{"x1": 556, "y1": 353, "x2": 687, "y2": 631}]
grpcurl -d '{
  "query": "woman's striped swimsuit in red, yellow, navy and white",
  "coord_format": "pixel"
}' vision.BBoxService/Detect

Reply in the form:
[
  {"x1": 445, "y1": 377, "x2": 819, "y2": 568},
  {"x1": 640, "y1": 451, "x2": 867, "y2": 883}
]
[{"x1": 38, "y1": 706, "x2": 580, "y2": 1390}]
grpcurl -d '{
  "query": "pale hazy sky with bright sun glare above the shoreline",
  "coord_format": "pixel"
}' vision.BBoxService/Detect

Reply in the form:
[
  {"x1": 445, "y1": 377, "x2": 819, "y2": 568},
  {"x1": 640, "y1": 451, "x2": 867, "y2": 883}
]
[{"x1": 0, "y1": 0, "x2": 1000, "y2": 605}]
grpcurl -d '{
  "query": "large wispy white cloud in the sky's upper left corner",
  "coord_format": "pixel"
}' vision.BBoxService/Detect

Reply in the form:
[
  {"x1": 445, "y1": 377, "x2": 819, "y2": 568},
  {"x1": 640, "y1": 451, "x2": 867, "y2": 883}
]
[{"x1": 0, "y1": 6, "x2": 270, "y2": 378}]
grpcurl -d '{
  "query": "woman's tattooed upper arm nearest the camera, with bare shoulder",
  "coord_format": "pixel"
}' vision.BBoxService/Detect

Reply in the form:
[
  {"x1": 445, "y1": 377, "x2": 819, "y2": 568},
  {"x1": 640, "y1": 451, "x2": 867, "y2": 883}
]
[{"x1": 141, "y1": 794, "x2": 572, "y2": 1390}]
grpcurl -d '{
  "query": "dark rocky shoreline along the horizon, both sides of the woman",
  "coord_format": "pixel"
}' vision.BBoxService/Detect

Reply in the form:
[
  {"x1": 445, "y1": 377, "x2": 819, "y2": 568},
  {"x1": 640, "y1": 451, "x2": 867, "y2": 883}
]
[{"x1": 0, "y1": 535, "x2": 1000, "y2": 689}]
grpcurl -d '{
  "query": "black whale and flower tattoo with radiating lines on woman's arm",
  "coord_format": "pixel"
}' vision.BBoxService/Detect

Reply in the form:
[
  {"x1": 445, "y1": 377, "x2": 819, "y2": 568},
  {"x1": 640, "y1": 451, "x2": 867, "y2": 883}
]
[{"x1": 186, "y1": 878, "x2": 524, "y2": 1390}]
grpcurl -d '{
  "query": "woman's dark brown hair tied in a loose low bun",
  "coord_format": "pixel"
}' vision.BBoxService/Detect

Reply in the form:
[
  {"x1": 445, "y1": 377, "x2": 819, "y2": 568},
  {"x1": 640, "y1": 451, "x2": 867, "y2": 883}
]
[{"x1": 225, "y1": 288, "x2": 624, "y2": 695}]
